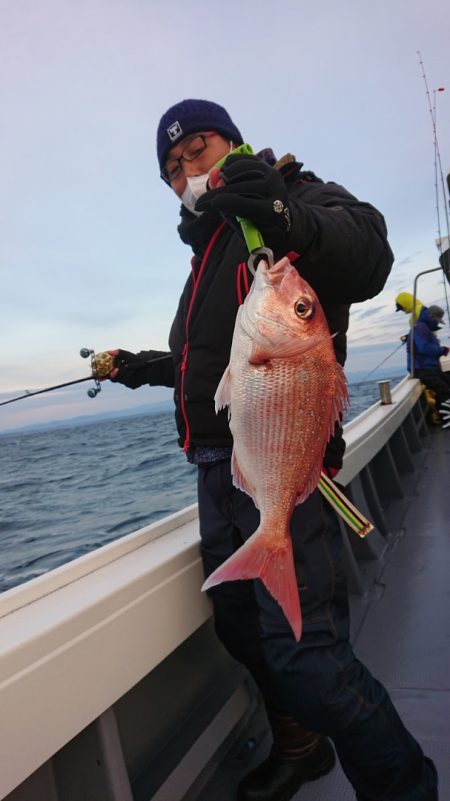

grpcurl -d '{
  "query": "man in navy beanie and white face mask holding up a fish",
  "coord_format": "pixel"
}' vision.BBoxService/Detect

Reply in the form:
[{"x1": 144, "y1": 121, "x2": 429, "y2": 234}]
[{"x1": 110, "y1": 99, "x2": 437, "y2": 801}]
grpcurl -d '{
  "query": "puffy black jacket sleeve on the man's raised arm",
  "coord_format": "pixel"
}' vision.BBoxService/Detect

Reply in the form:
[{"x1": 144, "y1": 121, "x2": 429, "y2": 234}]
[{"x1": 288, "y1": 182, "x2": 394, "y2": 303}]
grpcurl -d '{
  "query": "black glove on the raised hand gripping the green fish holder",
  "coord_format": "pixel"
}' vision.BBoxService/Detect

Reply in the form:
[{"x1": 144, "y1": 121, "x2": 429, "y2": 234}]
[{"x1": 195, "y1": 154, "x2": 291, "y2": 250}]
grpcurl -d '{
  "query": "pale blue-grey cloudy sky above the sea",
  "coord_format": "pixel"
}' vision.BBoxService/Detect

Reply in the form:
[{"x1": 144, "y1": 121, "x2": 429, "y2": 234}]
[{"x1": 0, "y1": 0, "x2": 450, "y2": 431}]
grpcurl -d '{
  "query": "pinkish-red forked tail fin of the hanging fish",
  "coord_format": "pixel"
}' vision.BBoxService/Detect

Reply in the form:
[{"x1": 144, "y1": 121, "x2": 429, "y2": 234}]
[{"x1": 202, "y1": 531, "x2": 302, "y2": 642}]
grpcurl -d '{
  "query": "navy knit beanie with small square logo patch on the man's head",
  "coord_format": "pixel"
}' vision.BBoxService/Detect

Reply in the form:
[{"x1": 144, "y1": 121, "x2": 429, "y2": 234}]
[{"x1": 156, "y1": 100, "x2": 244, "y2": 170}]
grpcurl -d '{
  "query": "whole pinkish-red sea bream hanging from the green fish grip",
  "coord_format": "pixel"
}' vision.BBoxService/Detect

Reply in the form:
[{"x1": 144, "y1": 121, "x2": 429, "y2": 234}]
[{"x1": 202, "y1": 258, "x2": 348, "y2": 640}]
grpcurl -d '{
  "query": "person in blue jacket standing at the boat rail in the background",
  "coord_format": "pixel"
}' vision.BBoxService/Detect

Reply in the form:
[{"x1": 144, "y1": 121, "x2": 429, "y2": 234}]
[{"x1": 406, "y1": 298, "x2": 450, "y2": 412}]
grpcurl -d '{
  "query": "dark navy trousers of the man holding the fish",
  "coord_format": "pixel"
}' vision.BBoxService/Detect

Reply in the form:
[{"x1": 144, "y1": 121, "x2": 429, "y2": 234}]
[{"x1": 198, "y1": 460, "x2": 438, "y2": 801}]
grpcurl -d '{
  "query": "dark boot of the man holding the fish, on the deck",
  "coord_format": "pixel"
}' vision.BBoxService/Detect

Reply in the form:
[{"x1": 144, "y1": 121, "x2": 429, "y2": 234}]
[{"x1": 237, "y1": 711, "x2": 336, "y2": 801}]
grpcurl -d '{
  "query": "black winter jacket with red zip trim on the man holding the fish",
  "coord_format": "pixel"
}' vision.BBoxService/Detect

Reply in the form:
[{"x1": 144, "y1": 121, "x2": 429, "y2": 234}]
[{"x1": 139, "y1": 162, "x2": 393, "y2": 469}]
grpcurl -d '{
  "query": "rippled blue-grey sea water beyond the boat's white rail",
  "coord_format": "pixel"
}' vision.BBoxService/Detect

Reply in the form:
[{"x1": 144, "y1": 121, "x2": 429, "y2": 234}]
[{"x1": 0, "y1": 379, "x2": 399, "y2": 592}]
